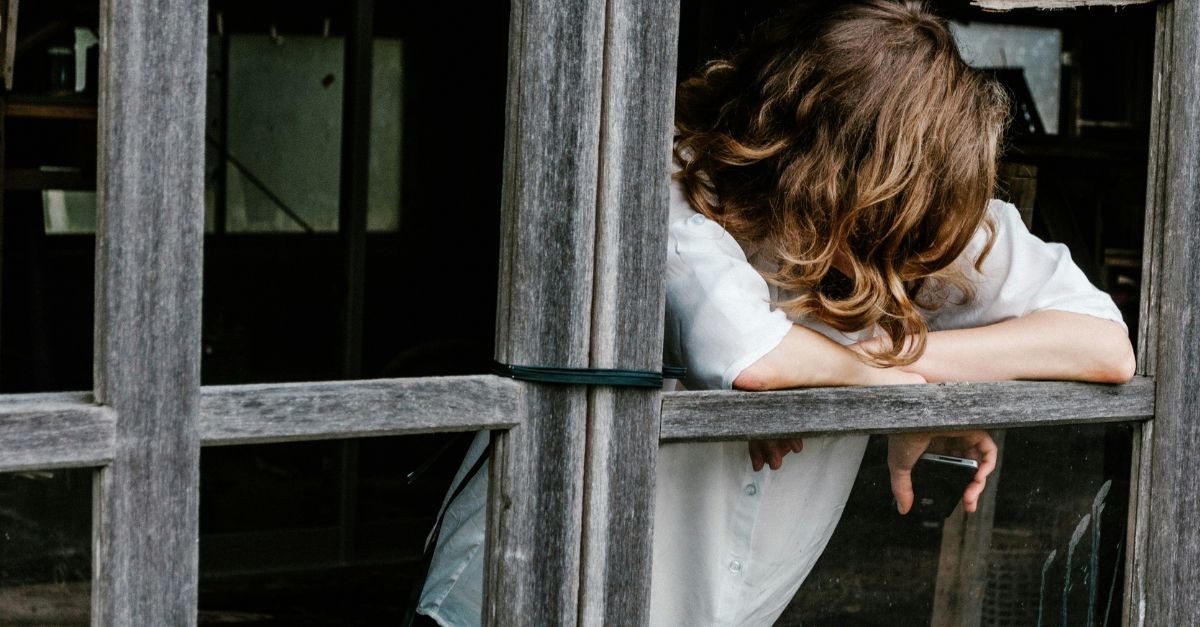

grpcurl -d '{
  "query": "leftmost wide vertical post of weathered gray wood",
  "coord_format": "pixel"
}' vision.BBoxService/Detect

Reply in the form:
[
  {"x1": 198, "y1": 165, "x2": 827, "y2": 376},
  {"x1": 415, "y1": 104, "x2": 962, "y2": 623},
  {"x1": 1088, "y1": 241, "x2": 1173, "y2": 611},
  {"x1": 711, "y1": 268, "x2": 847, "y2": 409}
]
[{"x1": 91, "y1": 0, "x2": 208, "y2": 626}]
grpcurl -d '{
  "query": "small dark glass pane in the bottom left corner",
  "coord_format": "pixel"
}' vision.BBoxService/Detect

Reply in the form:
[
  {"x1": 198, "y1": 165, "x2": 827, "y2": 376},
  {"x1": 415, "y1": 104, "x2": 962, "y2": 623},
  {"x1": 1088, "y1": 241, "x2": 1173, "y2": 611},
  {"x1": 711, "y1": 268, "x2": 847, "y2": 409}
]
[{"x1": 0, "y1": 468, "x2": 92, "y2": 625}]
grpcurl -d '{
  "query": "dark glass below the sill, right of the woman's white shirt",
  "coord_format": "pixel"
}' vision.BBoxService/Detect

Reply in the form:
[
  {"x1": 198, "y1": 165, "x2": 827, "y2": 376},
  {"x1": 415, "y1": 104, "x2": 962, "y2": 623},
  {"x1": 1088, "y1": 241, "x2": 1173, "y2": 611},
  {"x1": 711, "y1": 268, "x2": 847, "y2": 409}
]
[{"x1": 779, "y1": 424, "x2": 1133, "y2": 627}]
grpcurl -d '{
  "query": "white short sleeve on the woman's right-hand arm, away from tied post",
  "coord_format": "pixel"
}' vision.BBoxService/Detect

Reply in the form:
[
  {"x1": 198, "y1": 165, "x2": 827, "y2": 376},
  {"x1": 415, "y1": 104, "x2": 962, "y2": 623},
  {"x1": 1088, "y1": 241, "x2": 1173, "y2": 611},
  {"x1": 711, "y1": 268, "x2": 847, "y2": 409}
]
[{"x1": 929, "y1": 201, "x2": 1128, "y2": 330}]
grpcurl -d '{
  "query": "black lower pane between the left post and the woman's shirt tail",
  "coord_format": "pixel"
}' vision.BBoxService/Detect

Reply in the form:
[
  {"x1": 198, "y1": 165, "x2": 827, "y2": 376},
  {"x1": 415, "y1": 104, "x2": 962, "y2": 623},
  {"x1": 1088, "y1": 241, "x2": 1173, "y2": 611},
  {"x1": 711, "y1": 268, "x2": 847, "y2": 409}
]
[{"x1": 200, "y1": 434, "x2": 472, "y2": 626}]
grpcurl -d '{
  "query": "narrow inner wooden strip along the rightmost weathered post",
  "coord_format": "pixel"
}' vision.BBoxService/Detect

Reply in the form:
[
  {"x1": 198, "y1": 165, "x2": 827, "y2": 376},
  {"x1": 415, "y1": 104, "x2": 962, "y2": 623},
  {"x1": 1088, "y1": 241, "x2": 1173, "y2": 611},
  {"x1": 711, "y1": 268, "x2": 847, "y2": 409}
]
[{"x1": 1121, "y1": 2, "x2": 1175, "y2": 626}]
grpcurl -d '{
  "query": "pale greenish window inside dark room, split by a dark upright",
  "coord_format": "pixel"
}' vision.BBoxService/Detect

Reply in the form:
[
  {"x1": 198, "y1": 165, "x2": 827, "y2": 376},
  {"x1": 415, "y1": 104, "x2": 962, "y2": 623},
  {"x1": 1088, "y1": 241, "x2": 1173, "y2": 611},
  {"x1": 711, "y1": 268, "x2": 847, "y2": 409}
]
[{"x1": 206, "y1": 35, "x2": 402, "y2": 233}]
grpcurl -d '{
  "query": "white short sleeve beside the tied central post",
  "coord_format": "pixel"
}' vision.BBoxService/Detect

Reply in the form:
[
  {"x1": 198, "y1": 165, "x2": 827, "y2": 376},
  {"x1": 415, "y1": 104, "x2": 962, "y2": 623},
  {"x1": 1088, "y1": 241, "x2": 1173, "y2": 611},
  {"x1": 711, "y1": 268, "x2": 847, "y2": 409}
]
[{"x1": 665, "y1": 181, "x2": 792, "y2": 389}]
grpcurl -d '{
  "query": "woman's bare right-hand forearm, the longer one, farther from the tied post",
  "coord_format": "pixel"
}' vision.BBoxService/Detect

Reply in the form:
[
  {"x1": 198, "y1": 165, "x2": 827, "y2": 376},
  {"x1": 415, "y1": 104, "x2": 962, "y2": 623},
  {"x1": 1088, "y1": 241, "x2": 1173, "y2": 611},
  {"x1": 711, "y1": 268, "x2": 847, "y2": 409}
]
[{"x1": 904, "y1": 310, "x2": 1134, "y2": 383}]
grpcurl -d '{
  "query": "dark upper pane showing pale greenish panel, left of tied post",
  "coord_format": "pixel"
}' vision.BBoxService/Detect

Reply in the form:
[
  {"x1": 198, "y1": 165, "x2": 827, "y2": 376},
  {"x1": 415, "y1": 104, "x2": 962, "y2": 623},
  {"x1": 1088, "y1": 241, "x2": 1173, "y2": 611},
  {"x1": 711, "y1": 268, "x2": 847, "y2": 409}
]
[{"x1": 202, "y1": 1, "x2": 508, "y2": 384}]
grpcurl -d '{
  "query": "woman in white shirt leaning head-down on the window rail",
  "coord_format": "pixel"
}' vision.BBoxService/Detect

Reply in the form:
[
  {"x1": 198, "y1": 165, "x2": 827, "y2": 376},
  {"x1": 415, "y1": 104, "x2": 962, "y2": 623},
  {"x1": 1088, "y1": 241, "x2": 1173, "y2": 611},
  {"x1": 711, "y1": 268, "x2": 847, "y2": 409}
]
[{"x1": 420, "y1": 0, "x2": 1133, "y2": 625}]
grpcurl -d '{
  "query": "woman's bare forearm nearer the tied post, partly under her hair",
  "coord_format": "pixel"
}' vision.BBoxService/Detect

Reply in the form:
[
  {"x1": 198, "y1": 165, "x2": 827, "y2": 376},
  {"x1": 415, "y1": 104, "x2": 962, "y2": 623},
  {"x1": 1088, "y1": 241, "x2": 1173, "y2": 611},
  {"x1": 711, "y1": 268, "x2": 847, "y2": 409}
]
[{"x1": 733, "y1": 324, "x2": 924, "y2": 392}]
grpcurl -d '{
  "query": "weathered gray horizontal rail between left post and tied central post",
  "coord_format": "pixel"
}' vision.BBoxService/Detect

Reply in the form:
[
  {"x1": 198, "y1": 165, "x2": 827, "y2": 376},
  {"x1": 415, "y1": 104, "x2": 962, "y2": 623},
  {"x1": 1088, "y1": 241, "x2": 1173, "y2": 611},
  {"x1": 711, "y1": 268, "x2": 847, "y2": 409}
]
[{"x1": 200, "y1": 375, "x2": 524, "y2": 446}]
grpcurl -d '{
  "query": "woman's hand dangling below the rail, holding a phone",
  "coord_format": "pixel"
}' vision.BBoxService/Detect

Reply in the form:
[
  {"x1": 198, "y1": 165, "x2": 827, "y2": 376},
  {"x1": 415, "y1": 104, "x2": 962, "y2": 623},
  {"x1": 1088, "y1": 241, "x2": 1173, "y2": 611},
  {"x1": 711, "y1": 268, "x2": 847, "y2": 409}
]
[{"x1": 888, "y1": 430, "x2": 1000, "y2": 514}]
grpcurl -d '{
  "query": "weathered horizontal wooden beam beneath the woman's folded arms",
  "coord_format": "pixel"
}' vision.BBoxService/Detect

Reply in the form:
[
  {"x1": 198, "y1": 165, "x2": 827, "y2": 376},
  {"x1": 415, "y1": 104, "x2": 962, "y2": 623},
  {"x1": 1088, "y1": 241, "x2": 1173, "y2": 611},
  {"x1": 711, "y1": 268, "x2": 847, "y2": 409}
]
[{"x1": 660, "y1": 377, "x2": 1154, "y2": 441}]
